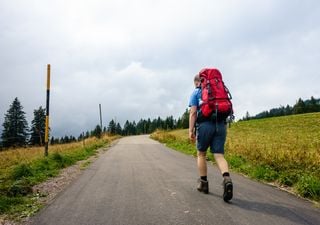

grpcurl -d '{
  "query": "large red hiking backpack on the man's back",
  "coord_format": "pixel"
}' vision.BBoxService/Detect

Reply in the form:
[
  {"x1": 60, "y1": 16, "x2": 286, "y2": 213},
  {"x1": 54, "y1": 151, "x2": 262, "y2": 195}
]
[{"x1": 199, "y1": 68, "x2": 233, "y2": 120}]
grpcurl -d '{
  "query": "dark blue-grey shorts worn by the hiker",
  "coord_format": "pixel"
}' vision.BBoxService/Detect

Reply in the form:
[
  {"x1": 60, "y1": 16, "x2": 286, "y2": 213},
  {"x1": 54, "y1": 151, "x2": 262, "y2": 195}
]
[{"x1": 197, "y1": 121, "x2": 227, "y2": 154}]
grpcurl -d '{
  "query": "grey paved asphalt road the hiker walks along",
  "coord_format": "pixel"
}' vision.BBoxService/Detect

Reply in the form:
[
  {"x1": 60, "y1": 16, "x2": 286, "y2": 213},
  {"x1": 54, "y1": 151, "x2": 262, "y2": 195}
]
[{"x1": 33, "y1": 136, "x2": 320, "y2": 225}]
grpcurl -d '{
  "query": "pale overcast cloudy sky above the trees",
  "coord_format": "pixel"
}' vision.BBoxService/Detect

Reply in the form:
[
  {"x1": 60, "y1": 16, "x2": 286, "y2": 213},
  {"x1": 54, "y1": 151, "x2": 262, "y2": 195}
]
[{"x1": 0, "y1": 0, "x2": 320, "y2": 136}]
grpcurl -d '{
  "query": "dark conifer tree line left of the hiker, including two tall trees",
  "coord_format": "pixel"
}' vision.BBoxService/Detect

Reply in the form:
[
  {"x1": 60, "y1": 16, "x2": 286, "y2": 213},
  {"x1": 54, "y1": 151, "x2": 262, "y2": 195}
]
[{"x1": 0, "y1": 97, "x2": 189, "y2": 150}]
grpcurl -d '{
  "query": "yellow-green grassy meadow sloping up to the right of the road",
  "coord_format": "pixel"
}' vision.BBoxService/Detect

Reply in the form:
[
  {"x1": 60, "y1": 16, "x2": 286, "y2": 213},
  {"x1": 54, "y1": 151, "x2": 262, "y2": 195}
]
[{"x1": 151, "y1": 113, "x2": 320, "y2": 202}]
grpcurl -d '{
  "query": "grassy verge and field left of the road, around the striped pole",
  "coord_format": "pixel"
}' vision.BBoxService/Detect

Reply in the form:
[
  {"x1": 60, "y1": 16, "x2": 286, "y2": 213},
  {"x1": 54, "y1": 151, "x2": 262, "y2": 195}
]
[{"x1": 0, "y1": 136, "x2": 118, "y2": 219}]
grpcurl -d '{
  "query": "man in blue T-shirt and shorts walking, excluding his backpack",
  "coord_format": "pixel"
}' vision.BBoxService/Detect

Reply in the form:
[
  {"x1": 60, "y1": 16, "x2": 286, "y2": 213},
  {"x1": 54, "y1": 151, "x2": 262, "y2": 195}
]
[{"x1": 189, "y1": 72, "x2": 233, "y2": 202}]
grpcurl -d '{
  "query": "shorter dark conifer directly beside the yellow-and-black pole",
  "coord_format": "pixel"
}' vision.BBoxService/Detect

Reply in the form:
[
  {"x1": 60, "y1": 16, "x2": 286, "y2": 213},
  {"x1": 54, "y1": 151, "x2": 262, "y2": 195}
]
[{"x1": 29, "y1": 106, "x2": 46, "y2": 146}]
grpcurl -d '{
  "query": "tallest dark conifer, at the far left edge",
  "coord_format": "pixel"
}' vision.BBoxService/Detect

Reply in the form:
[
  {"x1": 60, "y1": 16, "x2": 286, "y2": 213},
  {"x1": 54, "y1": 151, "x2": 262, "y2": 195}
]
[{"x1": 1, "y1": 98, "x2": 28, "y2": 147}]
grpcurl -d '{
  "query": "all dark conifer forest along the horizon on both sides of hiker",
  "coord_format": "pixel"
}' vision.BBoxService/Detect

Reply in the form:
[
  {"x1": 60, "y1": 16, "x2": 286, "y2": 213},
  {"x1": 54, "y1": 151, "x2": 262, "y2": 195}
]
[{"x1": 0, "y1": 96, "x2": 320, "y2": 150}]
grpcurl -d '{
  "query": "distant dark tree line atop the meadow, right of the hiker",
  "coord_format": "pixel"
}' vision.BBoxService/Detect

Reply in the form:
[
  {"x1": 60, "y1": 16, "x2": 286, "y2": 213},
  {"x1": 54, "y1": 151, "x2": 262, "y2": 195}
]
[{"x1": 241, "y1": 96, "x2": 320, "y2": 120}]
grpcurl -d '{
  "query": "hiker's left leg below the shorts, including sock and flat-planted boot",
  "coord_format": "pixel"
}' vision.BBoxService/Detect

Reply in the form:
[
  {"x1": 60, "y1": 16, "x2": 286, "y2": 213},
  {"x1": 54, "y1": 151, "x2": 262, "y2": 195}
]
[{"x1": 197, "y1": 151, "x2": 209, "y2": 194}]
